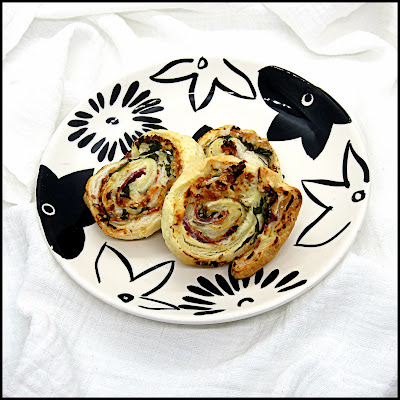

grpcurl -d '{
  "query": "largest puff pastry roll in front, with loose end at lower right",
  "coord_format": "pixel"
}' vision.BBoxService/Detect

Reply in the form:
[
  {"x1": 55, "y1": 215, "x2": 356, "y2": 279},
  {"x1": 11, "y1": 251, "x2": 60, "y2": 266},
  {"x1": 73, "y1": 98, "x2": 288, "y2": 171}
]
[{"x1": 161, "y1": 155, "x2": 302, "y2": 279}]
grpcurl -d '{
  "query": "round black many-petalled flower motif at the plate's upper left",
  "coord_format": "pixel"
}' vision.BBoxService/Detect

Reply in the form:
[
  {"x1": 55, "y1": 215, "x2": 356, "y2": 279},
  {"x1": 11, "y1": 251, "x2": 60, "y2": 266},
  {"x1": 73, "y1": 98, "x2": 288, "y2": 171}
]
[{"x1": 68, "y1": 81, "x2": 166, "y2": 162}]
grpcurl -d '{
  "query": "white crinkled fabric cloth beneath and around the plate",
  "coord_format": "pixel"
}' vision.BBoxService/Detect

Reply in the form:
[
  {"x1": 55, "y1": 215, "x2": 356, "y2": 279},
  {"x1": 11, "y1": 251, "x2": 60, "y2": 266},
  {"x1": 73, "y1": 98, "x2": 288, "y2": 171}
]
[{"x1": 3, "y1": 2, "x2": 398, "y2": 397}]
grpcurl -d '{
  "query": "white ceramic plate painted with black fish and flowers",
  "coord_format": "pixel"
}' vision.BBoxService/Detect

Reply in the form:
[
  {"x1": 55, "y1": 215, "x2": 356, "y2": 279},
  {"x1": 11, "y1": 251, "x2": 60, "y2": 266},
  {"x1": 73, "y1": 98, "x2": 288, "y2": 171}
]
[{"x1": 37, "y1": 57, "x2": 370, "y2": 324}]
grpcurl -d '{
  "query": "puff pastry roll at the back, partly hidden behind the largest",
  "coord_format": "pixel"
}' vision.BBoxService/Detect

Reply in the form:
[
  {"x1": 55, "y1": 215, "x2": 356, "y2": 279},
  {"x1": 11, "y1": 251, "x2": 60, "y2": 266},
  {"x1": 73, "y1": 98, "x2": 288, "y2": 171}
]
[{"x1": 199, "y1": 125, "x2": 281, "y2": 174}]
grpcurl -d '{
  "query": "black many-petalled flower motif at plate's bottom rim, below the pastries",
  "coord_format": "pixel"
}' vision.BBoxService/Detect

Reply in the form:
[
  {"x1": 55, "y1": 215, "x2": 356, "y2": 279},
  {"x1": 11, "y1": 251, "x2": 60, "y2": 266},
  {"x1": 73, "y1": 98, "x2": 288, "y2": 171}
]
[{"x1": 179, "y1": 268, "x2": 307, "y2": 315}]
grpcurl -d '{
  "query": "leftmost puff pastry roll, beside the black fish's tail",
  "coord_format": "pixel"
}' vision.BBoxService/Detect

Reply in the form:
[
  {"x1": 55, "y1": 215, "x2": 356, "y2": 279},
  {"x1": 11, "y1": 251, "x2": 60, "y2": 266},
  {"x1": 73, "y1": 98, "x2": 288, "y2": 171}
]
[{"x1": 84, "y1": 130, "x2": 205, "y2": 240}]
